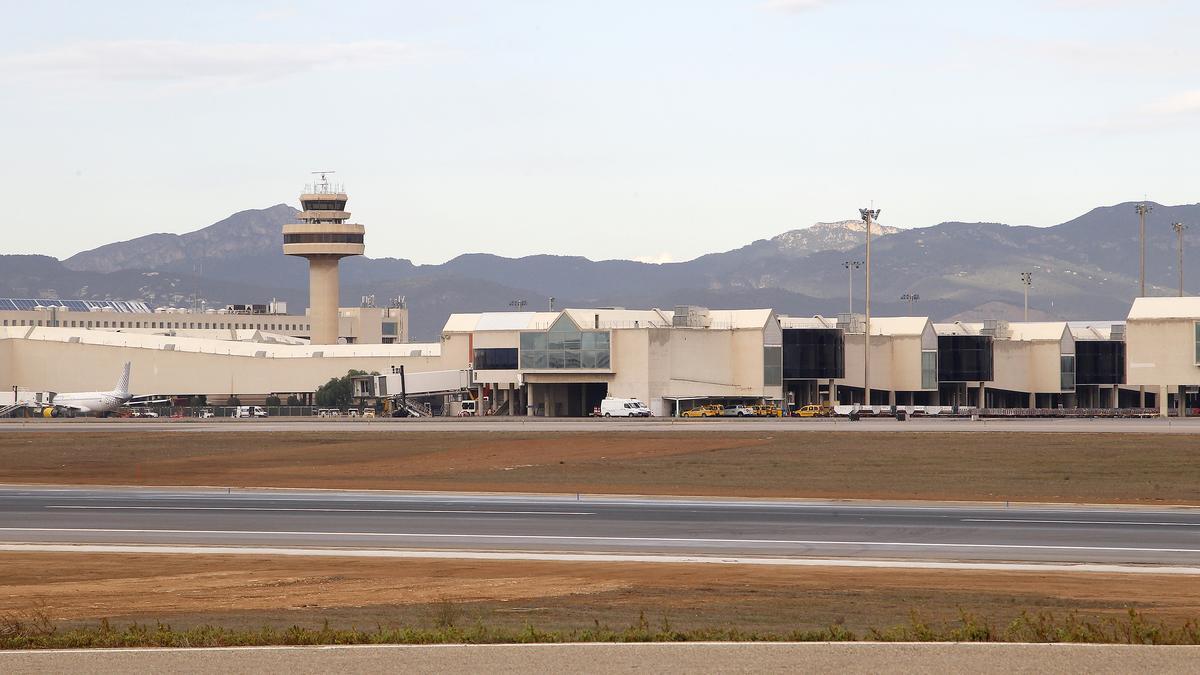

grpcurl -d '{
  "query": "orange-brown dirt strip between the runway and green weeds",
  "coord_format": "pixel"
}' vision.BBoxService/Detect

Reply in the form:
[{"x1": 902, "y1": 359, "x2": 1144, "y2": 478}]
[{"x1": 0, "y1": 552, "x2": 1200, "y2": 632}]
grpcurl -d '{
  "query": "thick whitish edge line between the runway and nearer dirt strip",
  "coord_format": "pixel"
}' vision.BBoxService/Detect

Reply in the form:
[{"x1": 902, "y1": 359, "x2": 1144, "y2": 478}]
[{"x1": 0, "y1": 543, "x2": 1200, "y2": 575}]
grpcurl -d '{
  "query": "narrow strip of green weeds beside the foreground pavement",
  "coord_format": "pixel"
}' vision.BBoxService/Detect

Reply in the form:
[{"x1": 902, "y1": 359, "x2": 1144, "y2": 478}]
[{"x1": 0, "y1": 610, "x2": 1200, "y2": 650}]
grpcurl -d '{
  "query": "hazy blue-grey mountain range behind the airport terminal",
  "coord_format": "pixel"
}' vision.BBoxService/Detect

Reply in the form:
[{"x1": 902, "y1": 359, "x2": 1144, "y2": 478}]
[{"x1": 0, "y1": 202, "x2": 1200, "y2": 340}]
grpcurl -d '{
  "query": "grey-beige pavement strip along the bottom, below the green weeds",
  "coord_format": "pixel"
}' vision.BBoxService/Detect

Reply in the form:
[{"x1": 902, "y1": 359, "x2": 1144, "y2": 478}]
[{"x1": 0, "y1": 643, "x2": 1200, "y2": 675}]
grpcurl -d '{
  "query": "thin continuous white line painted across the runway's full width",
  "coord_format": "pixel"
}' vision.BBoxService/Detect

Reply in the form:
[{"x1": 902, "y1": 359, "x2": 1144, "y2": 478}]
[{"x1": 0, "y1": 527, "x2": 1200, "y2": 554}]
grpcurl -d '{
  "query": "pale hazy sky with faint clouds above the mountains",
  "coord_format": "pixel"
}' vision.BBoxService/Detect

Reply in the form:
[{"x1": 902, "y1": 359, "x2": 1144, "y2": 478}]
[{"x1": 0, "y1": 0, "x2": 1200, "y2": 262}]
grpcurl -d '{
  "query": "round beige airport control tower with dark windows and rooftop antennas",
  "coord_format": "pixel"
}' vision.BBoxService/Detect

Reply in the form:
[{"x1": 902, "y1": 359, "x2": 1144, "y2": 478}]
[{"x1": 283, "y1": 171, "x2": 366, "y2": 345}]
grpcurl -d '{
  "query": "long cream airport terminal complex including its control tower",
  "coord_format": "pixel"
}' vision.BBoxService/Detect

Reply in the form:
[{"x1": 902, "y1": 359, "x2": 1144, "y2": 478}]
[{"x1": 0, "y1": 179, "x2": 1200, "y2": 417}]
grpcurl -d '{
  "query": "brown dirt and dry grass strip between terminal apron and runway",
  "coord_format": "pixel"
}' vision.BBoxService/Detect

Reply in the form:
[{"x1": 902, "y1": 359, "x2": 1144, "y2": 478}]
[{"x1": 0, "y1": 431, "x2": 1200, "y2": 504}]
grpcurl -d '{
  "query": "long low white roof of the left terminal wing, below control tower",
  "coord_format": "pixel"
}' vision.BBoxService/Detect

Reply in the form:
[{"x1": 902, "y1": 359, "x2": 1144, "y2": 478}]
[{"x1": 0, "y1": 325, "x2": 442, "y2": 358}]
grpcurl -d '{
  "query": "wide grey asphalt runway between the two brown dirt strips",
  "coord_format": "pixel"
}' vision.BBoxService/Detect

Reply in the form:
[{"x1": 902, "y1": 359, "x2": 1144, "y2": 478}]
[{"x1": 0, "y1": 486, "x2": 1200, "y2": 567}]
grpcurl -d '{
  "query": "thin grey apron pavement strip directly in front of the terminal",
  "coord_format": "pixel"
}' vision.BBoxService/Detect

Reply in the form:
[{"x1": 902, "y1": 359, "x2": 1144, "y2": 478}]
[{"x1": 0, "y1": 417, "x2": 1200, "y2": 434}]
